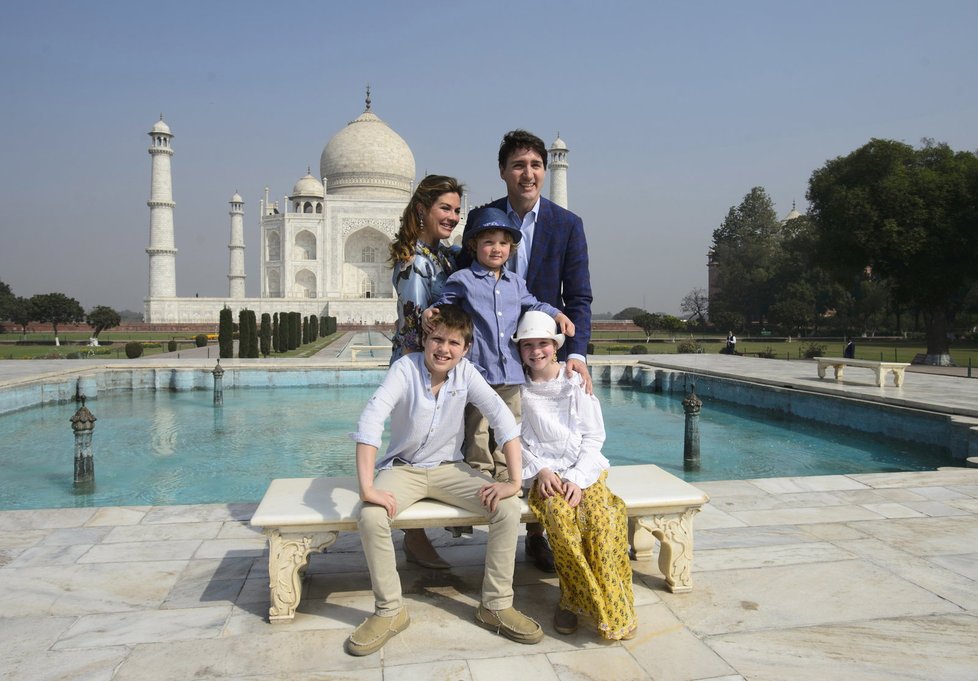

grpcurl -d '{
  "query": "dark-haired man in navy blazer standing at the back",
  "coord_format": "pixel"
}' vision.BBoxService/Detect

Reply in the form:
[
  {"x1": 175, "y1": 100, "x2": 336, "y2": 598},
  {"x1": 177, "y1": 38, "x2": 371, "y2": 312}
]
[{"x1": 459, "y1": 130, "x2": 592, "y2": 382}]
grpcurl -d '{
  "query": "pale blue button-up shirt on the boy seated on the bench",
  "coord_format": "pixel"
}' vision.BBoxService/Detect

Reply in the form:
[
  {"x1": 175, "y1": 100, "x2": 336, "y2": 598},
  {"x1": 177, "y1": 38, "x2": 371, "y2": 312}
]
[{"x1": 350, "y1": 352, "x2": 520, "y2": 470}]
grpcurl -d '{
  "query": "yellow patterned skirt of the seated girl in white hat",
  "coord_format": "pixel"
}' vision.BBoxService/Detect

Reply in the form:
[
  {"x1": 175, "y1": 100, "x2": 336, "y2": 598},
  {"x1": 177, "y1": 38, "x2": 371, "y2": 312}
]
[{"x1": 529, "y1": 471, "x2": 638, "y2": 640}]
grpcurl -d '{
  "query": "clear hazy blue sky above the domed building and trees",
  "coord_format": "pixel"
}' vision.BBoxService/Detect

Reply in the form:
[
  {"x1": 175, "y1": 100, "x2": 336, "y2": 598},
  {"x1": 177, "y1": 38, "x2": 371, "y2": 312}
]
[{"x1": 0, "y1": 0, "x2": 978, "y2": 313}]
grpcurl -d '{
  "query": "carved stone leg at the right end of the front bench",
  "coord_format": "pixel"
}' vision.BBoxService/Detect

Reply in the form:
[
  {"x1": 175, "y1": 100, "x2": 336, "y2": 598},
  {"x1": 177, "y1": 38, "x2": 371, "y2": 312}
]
[{"x1": 629, "y1": 508, "x2": 700, "y2": 593}]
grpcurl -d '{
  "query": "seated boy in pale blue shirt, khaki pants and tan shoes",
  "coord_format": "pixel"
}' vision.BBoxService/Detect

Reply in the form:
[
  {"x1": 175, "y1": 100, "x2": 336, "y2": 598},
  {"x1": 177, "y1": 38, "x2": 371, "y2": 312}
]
[{"x1": 345, "y1": 305, "x2": 543, "y2": 656}]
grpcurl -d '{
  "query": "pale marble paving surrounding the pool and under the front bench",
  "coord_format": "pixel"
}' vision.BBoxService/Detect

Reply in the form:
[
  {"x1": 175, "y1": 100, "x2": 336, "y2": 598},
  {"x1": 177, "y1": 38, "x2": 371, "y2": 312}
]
[{"x1": 0, "y1": 358, "x2": 978, "y2": 681}]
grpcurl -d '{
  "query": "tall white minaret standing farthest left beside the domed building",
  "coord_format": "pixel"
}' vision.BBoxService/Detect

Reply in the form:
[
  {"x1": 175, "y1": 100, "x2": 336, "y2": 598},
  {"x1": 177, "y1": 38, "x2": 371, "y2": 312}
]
[{"x1": 146, "y1": 114, "x2": 177, "y2": 298}]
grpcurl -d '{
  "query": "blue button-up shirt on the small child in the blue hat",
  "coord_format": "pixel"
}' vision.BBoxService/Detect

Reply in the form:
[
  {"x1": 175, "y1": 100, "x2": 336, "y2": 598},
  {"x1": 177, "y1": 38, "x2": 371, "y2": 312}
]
[{"x1": 435, "y1": 262, "x2": 560, "y2": 385}]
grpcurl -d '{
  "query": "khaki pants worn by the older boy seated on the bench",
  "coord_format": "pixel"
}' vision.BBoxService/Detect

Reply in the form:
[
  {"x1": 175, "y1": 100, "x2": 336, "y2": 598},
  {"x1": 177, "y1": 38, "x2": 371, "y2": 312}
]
[{"x1": 360, "y1": 461, "x2": 520, "y2": 617}]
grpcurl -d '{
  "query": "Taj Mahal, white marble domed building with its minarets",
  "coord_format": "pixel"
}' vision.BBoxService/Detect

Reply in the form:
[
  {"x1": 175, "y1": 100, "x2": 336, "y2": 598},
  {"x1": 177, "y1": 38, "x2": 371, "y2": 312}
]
[{"x1": 144, "y1": 88, "x2": 567, "y2": 324}]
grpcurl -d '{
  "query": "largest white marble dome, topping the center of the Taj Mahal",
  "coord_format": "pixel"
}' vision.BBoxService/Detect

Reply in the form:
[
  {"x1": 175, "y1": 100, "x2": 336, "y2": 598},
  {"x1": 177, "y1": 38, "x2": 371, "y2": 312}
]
[{"x1": 319, "y1": 105, "x2": 414, "y2": 199}]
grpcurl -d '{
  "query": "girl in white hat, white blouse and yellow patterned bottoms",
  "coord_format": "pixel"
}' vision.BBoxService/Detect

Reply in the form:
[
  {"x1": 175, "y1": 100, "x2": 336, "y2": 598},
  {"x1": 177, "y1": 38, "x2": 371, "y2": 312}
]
[{"x1": 513, "y1": 311, "x2": 638, "y2": 640}]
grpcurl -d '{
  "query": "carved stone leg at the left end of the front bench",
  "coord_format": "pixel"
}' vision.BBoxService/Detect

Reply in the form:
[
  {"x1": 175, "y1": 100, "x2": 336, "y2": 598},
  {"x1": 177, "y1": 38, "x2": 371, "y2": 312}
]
[{"x1": 265, "y1": 529, "x2": 337, "y2": 624}]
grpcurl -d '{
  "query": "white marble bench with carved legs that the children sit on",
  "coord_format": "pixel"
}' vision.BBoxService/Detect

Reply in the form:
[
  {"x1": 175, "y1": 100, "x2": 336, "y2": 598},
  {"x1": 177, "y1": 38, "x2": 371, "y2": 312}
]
[{"x1": 251, "y1": 464, "x2": 709, "y2": 623}]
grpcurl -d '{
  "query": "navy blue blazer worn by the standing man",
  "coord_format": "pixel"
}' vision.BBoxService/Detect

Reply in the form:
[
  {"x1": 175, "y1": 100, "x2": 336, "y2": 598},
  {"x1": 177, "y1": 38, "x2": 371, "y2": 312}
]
[{"x1": 458, "y1": 196, "x2": 593, "y2": 359}]
